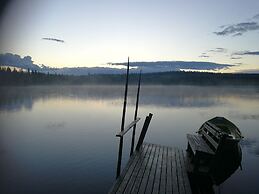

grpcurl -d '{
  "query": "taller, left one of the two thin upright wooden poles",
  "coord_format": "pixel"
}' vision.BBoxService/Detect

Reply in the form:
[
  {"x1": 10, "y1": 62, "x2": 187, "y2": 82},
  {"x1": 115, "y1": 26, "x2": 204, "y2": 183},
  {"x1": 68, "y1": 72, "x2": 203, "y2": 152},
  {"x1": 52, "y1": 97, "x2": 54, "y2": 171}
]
[{"x1": 116, "y1": 57, "x2": 129, "y2": 178}]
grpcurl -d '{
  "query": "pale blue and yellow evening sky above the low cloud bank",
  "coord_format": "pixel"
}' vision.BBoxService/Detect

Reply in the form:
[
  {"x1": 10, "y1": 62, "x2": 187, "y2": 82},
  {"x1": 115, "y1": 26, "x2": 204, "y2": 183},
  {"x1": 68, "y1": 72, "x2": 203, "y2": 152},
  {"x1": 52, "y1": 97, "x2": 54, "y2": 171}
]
[{"x1": 0, "y1": 0, "x2": 259, "y2": 72}]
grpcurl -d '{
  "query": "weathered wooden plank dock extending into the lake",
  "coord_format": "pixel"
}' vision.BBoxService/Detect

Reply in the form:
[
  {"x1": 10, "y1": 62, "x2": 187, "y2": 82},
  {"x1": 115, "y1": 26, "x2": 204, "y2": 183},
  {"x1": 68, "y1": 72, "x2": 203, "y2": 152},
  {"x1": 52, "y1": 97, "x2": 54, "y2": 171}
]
[{"x1": 109, "y1": 143, "x2": 192, "y2": 194}]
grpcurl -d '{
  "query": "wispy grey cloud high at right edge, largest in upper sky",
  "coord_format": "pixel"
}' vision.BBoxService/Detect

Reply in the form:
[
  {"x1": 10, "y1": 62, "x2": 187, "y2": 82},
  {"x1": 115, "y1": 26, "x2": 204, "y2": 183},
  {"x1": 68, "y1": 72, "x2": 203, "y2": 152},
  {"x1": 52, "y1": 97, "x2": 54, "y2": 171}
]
[{"x1": 214, "y1": 22, "x2": 259, "y2": 36}]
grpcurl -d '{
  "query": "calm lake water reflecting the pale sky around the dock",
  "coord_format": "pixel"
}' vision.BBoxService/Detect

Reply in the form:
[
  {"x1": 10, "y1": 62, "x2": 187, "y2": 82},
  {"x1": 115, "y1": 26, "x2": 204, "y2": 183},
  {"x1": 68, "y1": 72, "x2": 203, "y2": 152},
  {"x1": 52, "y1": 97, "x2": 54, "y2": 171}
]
[{"x1": 0, "y1": 86, "x2": 259, "y2": 194}]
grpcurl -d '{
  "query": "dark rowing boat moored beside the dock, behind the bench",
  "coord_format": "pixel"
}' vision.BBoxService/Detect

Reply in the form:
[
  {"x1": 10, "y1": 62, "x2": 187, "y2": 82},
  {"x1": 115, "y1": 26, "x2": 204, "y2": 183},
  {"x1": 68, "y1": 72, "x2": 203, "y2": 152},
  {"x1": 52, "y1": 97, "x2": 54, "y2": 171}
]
[{"x1": 189, "y1": 117, "x2": 243, "y2": 185}]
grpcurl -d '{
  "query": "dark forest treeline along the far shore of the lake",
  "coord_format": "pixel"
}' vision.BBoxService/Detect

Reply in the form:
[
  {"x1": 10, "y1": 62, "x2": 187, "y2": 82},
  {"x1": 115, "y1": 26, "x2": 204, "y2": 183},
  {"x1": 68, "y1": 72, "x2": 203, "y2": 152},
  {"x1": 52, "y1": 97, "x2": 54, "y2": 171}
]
[{"x1": 0, "y1": 67, "x2": 259, "y2": 86}]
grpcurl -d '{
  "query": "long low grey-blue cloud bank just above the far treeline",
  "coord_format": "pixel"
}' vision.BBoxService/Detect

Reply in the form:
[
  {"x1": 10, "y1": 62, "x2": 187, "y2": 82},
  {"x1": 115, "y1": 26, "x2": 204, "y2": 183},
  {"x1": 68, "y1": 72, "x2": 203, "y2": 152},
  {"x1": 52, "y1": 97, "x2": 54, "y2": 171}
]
[{"x1": 0, "y1": 53, "x2": 236, "y2": 75}]
